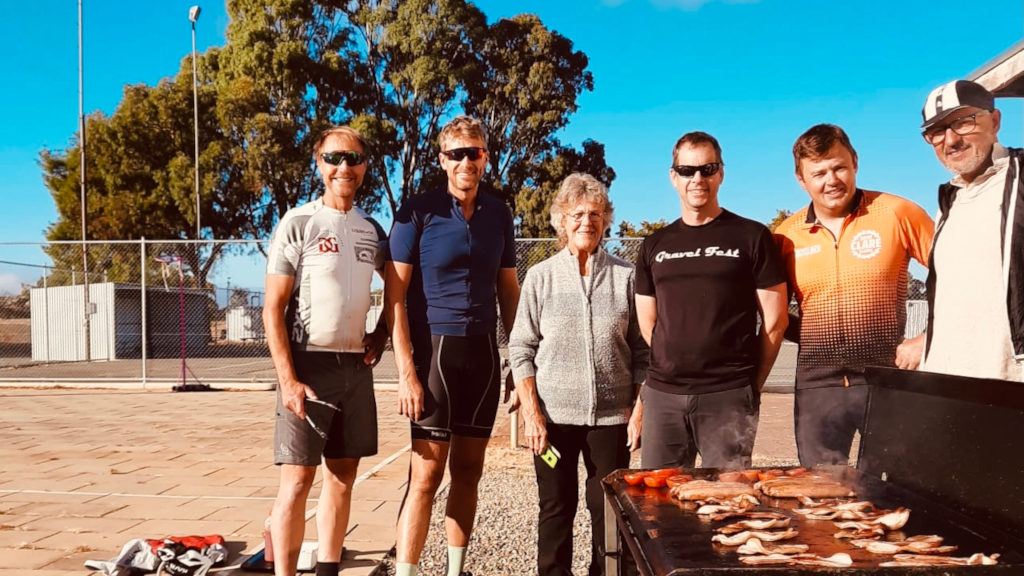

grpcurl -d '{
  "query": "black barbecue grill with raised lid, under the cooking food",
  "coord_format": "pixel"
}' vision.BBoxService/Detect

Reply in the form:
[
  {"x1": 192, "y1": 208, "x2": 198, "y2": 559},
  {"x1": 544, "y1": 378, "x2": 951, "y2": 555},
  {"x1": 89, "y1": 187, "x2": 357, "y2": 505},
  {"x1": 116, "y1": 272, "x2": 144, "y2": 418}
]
[{"x1": 603, "y1": 368, "x2": 1024, "y2": 576}]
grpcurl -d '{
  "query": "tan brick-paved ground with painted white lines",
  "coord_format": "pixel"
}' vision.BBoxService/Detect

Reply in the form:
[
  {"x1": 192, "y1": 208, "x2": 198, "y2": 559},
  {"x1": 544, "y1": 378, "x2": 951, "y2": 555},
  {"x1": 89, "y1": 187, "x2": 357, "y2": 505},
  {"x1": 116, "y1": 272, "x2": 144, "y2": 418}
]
[{"x1": 0, "y1": 366, "x2": 796, "y2": 576}]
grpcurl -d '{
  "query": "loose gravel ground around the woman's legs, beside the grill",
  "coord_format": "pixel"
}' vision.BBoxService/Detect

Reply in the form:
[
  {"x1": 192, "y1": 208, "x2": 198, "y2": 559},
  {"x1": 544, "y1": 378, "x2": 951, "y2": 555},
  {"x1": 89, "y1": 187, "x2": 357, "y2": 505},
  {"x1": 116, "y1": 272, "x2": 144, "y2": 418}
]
[{"x1": 378, "y1": 441, "x2": 797, "y2": 576}]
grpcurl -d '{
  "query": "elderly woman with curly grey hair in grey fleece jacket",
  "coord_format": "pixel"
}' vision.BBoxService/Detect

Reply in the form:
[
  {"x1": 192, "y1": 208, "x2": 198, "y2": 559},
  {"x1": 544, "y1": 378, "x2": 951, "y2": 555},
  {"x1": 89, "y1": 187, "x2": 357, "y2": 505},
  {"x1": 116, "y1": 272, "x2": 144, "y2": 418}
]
[{"x1": 509, "y1": 173, "x2": 648, "y2": 576}]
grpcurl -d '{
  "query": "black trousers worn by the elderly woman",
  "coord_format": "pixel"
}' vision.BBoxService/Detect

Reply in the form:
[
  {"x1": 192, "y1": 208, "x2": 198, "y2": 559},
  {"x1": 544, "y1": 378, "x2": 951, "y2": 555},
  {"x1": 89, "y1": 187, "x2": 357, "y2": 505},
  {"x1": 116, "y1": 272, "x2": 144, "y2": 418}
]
[{"x1": 534, "y1": 416, "x2": 630, "y2": 576}]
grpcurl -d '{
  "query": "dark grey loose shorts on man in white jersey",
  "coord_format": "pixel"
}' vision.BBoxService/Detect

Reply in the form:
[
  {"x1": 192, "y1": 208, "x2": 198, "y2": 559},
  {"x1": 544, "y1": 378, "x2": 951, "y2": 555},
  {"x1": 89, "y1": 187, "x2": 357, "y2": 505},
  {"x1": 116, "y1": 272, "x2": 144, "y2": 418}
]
[{"x1": 273, "y1": 351, "x2": 377, "y2": 466}]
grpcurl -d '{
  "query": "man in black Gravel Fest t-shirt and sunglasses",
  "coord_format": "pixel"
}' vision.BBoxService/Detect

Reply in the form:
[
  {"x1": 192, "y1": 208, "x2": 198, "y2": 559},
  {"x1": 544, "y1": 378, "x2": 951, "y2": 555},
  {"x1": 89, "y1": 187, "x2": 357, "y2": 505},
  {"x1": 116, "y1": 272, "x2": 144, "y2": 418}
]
[{"x1": 631, "y1": 132, "x2": 787, "y2": 468}]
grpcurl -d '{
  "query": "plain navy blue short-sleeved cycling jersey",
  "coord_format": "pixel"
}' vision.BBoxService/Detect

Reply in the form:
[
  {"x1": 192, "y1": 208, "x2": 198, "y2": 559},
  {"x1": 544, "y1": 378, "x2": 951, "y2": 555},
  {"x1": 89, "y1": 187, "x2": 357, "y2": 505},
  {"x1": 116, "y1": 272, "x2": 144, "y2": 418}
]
[{"x1": 389, "y1": 189, "x2": 515, "y2": 336}]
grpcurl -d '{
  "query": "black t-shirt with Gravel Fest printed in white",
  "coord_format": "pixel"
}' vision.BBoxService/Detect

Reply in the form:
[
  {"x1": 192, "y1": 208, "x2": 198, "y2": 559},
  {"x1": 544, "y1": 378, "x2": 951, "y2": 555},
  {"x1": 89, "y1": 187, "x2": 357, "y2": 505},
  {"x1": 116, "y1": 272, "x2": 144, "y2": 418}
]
[{"x1": 636, "y1": 210, "x2": 785, "y2": 394}]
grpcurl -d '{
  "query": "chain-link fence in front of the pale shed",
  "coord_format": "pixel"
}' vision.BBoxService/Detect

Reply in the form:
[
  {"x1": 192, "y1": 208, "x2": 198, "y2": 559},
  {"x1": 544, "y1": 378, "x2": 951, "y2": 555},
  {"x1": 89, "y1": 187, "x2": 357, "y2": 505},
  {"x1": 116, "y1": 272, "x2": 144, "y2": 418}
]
[{"x1": 0, "y1": 239, "x2": 639, "y2": 385}]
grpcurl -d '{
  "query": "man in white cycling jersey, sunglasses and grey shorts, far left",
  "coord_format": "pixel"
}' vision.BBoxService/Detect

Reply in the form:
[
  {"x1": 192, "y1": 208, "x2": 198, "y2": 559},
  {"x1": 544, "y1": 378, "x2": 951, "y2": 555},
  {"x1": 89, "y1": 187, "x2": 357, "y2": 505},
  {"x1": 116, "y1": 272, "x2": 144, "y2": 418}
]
[{"x1": 263, "y1": 126, "x2": 387, "y2": 576}]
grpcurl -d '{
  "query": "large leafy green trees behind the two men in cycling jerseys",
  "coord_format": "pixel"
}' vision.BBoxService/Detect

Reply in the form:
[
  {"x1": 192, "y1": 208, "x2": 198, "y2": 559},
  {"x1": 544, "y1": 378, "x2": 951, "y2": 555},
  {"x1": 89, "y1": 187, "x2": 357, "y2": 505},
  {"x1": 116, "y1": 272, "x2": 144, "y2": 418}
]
[{"x1": 40, "y1": 0, "x2": 614, "y2": 262}]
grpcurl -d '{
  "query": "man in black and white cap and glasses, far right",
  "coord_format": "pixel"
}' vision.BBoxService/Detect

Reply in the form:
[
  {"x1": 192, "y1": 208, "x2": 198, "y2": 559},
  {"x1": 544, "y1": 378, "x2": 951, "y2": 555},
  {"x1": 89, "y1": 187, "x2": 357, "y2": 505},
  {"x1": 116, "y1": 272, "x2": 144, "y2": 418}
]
[{"x1": 922, "y1": 80, "x2": 1024, "y2": 381}]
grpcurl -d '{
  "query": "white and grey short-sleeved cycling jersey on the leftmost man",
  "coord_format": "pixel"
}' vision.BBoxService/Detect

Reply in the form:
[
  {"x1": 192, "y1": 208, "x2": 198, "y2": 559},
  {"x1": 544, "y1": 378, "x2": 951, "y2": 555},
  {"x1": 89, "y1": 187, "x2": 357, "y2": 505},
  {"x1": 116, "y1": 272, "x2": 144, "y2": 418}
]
[{"x1": 266, "y1": 198, "x2": 387, "y2": 353}]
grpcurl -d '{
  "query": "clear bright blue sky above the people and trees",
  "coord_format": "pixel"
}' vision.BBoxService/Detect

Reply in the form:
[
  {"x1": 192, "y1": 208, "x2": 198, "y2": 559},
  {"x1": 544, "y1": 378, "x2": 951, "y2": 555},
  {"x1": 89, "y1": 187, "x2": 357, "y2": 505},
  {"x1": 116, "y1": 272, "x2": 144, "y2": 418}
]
[{"x1": 0, "y1": 0, "x2": 1024, "y2": 293}]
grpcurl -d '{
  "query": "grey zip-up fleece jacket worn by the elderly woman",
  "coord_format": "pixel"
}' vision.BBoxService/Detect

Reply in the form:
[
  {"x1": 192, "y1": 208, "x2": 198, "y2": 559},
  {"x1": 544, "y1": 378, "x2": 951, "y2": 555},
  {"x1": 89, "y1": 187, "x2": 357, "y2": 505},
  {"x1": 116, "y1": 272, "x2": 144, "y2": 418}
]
[{"x1": 509, "y1": 243, "x2": 649, "y2": 426}]
